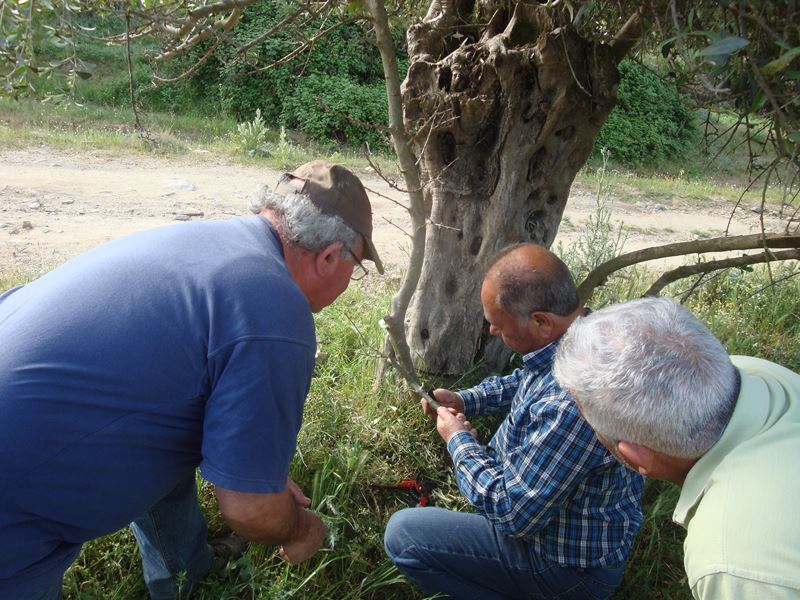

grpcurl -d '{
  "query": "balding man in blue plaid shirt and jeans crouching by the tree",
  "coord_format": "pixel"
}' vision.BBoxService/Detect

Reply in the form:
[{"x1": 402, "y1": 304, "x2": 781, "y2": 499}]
[{"x1": 384, "y1": 244, "x2": 642, "y2": 600}]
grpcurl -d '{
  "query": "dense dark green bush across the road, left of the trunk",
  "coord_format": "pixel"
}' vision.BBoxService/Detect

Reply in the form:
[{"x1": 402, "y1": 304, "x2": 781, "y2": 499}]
[{"x1": 186, "y1": 2, "x2": 400, "y2": 147}]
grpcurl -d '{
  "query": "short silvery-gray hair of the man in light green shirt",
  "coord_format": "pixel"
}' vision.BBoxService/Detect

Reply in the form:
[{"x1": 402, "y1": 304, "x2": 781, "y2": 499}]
[{"x1": 553, "y1": 298, "x2": 739, "y2": 458}]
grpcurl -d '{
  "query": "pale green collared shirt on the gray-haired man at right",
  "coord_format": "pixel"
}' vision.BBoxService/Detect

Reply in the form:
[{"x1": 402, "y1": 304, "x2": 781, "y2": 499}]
[{"x1": 673, "y1": 356, "x2": 800, "y2": 600}]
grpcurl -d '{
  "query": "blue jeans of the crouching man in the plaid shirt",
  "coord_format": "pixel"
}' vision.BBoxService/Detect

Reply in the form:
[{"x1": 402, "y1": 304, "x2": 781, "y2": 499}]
[{"x1": 384, "y1": 507, "x2": 624, "y2": 600}]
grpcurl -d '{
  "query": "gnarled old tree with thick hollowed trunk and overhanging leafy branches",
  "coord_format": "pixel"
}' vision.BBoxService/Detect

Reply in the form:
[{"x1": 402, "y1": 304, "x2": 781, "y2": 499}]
[{"x1": 0, "y1": 0, "x2": 800, "y2": 372}]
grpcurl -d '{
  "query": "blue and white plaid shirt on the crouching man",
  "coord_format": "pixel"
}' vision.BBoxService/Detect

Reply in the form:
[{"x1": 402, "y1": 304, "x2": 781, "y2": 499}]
[{"x1": 447, "y1": 340, "x2": 643, "y2": 568}]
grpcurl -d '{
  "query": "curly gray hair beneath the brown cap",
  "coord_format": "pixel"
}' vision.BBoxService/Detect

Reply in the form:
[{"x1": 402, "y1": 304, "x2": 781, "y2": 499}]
[{"x1": 250, "y1": 185, "x2": 359, "y2": 255}]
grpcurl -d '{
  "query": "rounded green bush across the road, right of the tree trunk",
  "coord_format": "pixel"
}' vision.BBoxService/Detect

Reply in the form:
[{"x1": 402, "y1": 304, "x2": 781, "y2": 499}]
[{"x1": 594, "y1": 61, "x2": 697, "y2": 165}]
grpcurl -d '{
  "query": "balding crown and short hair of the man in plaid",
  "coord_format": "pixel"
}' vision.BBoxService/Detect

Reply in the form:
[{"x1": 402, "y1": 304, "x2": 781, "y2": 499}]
[{"x1": 487, "y1": 243, "x2": 580, "y2": 319}]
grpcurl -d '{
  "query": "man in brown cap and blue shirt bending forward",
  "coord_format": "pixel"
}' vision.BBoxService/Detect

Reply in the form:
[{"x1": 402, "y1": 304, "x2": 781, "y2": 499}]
[{"x1": 0, "y1": 161, "x2": 382, "y2": 599}]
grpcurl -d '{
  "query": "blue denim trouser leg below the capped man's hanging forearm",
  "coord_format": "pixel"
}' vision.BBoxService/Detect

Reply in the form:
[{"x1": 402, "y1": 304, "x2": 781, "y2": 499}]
[{"x1": 131, "y1": 473, "x2": 213, "y2": 600}]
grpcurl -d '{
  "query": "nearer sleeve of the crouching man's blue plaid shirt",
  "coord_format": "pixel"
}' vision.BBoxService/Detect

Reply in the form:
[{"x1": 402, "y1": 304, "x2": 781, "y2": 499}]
[{"x1": 447, "y1": 390, "x2": 605, "y2": 536}]
